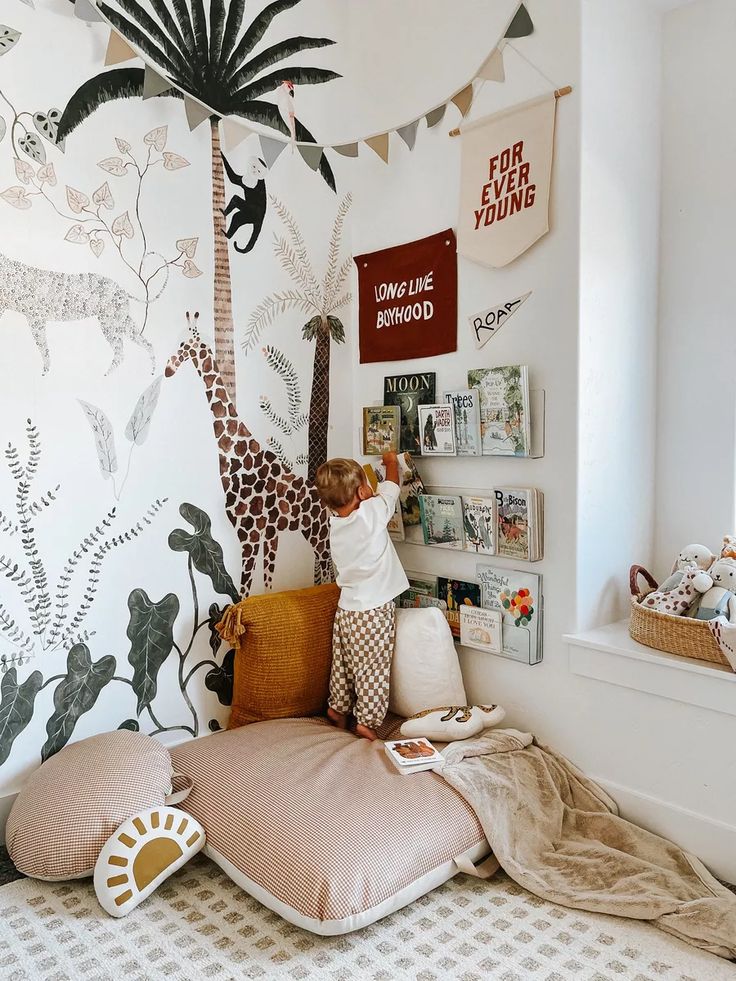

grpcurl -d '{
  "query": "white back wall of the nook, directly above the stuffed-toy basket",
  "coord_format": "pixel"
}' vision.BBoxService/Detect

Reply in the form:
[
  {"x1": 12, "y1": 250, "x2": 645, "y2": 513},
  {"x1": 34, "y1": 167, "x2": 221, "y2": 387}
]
[{"x1": 656, "y1": 0, "x2": 736, "y2": 576}]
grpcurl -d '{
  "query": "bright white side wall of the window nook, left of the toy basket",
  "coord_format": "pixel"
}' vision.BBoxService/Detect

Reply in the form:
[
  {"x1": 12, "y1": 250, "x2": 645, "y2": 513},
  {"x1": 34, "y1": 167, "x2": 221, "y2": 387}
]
[{"x1": 577, "y1": 0, "x2": 661, "y2": 627}]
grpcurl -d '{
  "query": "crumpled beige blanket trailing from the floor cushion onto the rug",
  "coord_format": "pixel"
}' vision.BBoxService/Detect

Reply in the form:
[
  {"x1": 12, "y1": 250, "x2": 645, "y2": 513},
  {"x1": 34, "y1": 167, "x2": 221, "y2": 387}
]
[{"x1": 438, "y1": 729, "x2": 736, "y2": 959}]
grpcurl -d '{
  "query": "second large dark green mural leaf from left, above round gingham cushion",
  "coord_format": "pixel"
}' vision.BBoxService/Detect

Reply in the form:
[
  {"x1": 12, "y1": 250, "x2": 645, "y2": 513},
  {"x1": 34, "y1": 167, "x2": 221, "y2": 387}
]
[{"x1": 41, "y1": 644, "x2": 115, "y2": 760}]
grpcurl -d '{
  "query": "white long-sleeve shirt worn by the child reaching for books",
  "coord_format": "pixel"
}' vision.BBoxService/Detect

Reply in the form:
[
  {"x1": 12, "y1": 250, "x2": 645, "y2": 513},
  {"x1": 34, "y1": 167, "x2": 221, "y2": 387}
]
[{"x1": 330, "y1": 480, "x2": 409, "y2": 610}]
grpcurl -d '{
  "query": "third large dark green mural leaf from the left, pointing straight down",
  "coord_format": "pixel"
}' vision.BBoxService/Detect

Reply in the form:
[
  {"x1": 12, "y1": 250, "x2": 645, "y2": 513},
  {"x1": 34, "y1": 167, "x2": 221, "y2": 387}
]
[{"x1": 127, "y1": 589, "x2": 179, "y2": 715}]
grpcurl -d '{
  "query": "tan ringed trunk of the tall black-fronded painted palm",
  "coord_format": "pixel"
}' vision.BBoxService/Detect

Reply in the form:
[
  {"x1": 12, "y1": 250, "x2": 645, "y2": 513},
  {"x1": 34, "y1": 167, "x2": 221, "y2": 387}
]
[{"x1": 210, "y1": 116, "x2": 236, "y2": 405}]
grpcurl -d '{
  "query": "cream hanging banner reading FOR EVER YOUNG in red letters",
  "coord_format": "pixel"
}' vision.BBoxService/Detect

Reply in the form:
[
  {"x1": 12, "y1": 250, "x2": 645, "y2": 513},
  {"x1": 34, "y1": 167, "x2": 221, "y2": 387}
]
[{"x1": 458, "y1": 92, "x2": 557, "y2": 267}]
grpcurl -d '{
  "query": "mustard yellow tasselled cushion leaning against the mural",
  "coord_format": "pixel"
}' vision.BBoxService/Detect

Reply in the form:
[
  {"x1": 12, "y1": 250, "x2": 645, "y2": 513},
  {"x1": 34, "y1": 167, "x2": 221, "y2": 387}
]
[{"x1": 218, "y1": 583, "x2": 340, "y2": 729}]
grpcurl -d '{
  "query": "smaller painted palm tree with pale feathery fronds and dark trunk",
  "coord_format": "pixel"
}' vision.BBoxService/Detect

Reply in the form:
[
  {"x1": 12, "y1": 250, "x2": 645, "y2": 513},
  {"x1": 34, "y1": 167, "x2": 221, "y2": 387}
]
[{"x1": 243, "y1": 194, "x2": 353, "y2": 480}]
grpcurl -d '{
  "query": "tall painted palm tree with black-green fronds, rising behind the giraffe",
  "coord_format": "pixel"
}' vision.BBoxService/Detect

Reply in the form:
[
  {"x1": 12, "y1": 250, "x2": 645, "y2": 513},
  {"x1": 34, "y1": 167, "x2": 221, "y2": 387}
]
[{"x1": 58, "y1": 0, "x2": 340, "y2": 404}]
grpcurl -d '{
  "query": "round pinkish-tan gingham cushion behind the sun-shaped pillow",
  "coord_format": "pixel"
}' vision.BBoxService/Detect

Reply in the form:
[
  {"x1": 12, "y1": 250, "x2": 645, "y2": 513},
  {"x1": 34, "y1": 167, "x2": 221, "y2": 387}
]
[{"x1": 5, "y1": 729, "x2": 172, "y2": 880}]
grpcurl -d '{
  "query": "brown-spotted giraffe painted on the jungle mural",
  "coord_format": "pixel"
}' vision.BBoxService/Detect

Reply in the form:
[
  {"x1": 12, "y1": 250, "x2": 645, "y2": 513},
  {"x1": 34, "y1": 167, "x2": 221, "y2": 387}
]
[{"x1": 165, "y1": 313, "x2": 333, "y2": 596}]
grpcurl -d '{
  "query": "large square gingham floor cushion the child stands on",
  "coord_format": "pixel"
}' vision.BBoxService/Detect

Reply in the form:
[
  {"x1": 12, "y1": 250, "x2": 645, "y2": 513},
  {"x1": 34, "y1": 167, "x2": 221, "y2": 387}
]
[{"x1": 172, "y1": 719, "x2": 487, "y2": 933}]
